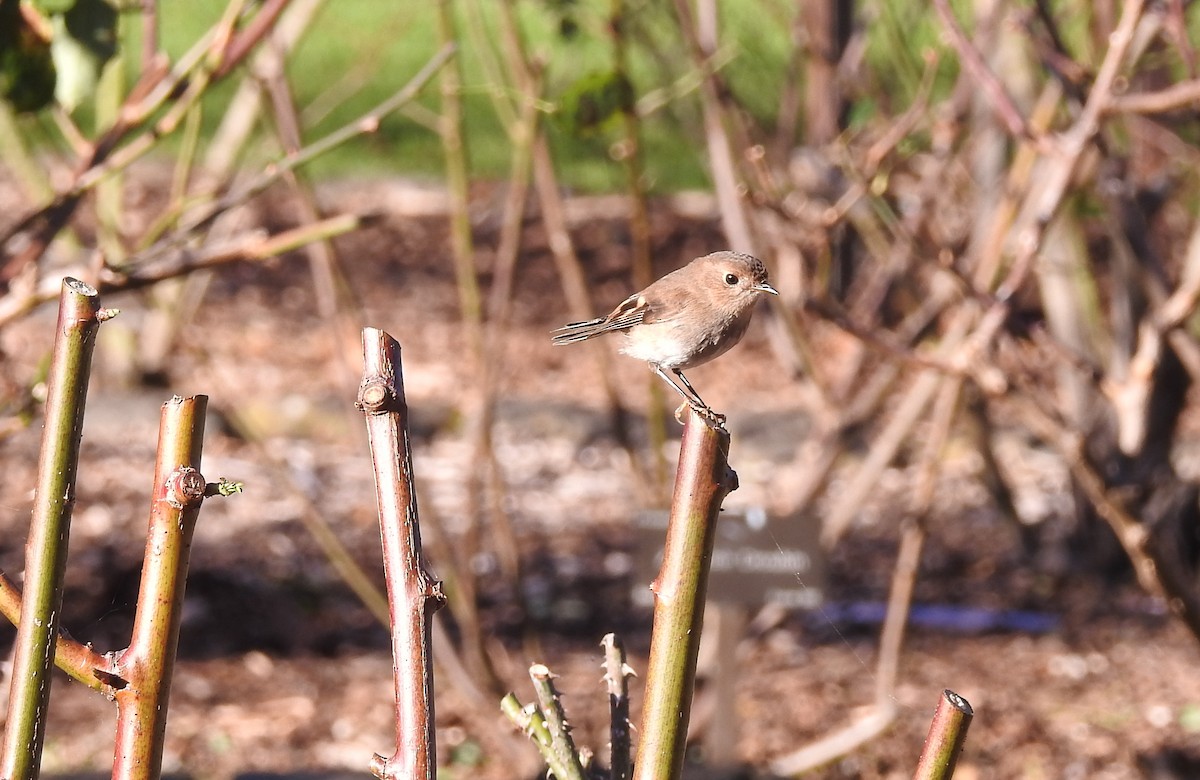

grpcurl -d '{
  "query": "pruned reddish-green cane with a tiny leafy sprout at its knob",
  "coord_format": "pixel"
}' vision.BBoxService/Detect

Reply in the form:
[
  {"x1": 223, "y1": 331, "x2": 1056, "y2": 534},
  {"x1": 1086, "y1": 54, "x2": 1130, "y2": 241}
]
[{"x1": 113, "y1": 396, "x2": 208, "y2": 780}]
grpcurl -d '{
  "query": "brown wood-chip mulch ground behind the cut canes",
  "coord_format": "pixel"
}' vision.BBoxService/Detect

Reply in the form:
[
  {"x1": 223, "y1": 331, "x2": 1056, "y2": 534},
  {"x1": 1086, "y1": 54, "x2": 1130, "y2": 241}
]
[{"x1": 0, "y1": 177, "x2": 1200, "y2": 780}]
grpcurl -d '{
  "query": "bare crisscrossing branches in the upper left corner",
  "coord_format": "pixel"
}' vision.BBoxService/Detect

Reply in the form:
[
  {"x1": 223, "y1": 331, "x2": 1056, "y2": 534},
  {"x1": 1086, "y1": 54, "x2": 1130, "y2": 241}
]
[{"x1": 0, "y1": 0, "x2": 454, "y2": 357}]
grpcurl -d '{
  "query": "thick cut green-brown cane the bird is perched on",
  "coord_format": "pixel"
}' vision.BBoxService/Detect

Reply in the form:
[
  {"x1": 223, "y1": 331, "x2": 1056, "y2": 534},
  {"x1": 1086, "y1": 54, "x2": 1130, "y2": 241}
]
[{"x1": 634, "y1": 408, "x2": 737, "y2": 780}]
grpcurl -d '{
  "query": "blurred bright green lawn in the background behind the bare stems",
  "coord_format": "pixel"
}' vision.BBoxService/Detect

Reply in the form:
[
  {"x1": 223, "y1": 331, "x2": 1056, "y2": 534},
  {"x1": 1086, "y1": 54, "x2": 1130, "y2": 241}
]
[{"x1": 25, "y1": 0, "x2": 1003, "y2": 192}]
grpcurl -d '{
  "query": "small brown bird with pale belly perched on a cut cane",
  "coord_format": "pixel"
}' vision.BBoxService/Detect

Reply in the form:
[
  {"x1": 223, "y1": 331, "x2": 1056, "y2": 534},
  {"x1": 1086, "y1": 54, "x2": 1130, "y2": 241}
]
[{"x1": 551, "y1": 251, "x2": 779, "y2": 426}]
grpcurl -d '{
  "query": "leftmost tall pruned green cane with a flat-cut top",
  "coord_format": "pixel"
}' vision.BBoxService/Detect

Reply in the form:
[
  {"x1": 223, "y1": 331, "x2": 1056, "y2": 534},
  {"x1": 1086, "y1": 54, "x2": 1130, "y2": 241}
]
[{"x1": 0, "y1": 278, "x2": 104, "y2": 780}]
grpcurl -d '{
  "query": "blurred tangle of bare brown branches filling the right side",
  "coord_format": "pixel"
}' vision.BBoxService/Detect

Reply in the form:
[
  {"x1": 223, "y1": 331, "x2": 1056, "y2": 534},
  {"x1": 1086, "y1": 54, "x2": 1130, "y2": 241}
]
[{"x1": 643, "y1": 0, "x2": 1200, "y2": 774}]
